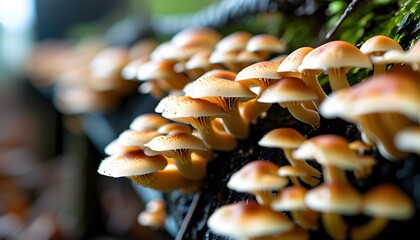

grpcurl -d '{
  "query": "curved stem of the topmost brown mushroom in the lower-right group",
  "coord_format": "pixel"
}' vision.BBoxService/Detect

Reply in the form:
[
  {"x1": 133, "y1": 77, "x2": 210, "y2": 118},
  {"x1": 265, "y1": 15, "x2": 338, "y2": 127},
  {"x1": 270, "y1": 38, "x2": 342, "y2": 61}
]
[{"x1": 283, "y1": 148, "x2": 321, "y2": 187}]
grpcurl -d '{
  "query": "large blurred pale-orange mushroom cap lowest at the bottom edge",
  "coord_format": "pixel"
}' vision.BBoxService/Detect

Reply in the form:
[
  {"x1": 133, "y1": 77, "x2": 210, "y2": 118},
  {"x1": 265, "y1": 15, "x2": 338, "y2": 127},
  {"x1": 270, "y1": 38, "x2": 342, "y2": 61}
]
[{"x1": 207, "y1": 201, "x2": 294, "y2": 239}]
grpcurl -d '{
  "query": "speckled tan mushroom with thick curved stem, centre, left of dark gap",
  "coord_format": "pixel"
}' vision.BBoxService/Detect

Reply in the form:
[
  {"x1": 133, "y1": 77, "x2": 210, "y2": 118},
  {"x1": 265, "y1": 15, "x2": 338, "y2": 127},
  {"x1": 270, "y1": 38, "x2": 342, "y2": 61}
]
[{"x1": 155, "y1": 95, "x2": 237, "y2": 151}]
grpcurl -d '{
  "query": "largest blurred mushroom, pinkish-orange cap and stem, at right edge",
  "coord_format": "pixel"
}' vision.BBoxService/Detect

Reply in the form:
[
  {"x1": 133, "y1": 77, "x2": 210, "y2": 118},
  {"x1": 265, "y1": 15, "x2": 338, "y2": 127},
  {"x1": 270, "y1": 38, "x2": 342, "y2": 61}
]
[{"x1": 320, "y1": 70, "x2": 420, "y2": 160}]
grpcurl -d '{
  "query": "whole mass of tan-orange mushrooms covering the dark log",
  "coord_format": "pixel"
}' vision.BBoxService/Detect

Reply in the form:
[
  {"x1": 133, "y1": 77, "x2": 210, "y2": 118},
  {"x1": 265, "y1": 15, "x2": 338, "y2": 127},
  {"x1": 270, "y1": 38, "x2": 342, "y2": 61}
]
[{"x1": 88, "y1": 28, "x2": 420, "y2": 239}]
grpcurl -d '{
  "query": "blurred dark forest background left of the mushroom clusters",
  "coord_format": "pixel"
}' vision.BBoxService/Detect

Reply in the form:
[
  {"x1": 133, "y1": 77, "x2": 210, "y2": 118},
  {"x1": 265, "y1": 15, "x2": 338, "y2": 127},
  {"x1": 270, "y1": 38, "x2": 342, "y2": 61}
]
[{"x1": 0, "y1": 0, "x2": 213, "y2": 240}]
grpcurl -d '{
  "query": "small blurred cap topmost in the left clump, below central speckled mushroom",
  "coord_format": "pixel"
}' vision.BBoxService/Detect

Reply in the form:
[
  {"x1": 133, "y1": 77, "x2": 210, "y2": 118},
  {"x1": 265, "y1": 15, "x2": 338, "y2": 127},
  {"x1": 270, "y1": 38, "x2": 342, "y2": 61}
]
[{"x1": 129, "y1": 113, "x2": 170, "y2": 131}]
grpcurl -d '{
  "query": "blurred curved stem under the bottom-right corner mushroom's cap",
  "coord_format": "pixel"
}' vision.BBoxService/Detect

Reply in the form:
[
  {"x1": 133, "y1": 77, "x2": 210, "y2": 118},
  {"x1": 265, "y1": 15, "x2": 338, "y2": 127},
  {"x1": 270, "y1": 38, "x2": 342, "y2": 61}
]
[{"x1": 350, "y1": 217, "x2": 389, "y2": 240}]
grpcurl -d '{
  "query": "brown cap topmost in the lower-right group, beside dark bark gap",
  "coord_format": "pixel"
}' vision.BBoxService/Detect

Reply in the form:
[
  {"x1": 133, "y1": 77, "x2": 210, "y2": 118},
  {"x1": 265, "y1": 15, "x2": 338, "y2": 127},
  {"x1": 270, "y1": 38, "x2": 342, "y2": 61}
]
[{"x1": 258, "y1": 127, "x2": 306, "y2": 148}]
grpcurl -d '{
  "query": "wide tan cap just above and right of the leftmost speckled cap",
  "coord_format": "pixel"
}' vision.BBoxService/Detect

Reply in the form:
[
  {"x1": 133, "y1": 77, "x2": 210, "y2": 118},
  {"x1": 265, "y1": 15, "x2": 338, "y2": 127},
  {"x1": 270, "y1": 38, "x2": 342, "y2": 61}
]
[{"x1": 144, "y1": 132, "x2": 207, "y2": 154}]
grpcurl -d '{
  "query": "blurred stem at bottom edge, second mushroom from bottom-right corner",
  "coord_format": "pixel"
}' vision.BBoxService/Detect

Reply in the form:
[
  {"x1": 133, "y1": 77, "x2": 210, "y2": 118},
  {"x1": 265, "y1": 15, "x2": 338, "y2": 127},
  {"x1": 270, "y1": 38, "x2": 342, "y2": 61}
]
[{"x1": 322, "y1": 212, "x2": 349, "y2": 240}]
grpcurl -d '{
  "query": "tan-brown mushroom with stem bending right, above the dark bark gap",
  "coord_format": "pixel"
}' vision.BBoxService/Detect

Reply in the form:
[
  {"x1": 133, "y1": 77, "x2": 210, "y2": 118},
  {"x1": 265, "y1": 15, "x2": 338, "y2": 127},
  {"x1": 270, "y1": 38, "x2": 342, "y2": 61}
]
[{"x1": 257, "y1": 77, "x2": 320, "y2": 128}]
